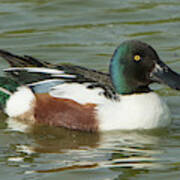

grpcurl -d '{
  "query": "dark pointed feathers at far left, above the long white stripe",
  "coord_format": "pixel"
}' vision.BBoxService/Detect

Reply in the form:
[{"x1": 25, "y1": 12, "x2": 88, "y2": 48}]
[{"x1": 0, "y1": 50, "x2": 51, "y2": 67}]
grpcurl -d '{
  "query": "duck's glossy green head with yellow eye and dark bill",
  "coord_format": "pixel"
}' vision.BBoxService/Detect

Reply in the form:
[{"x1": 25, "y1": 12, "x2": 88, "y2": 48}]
[{"x1": 110, "y1": 40, "x2": 180, "y2": 94}]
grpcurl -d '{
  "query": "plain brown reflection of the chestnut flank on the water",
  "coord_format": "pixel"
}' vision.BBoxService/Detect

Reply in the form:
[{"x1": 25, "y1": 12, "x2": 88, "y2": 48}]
[{"x1": 31, "y1": 126, "x2": 99, "y2": 153}]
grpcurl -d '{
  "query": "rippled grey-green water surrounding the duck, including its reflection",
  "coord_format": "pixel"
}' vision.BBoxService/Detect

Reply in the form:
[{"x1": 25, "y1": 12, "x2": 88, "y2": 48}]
[{"x1": 0, "y1": 0, "x2": 180, "y2": 180}]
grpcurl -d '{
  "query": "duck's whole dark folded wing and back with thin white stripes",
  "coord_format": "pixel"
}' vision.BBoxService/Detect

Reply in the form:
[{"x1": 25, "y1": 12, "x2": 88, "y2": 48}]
[{"x1": 0, "y1": 50, "x2": 116, "y2": 98}]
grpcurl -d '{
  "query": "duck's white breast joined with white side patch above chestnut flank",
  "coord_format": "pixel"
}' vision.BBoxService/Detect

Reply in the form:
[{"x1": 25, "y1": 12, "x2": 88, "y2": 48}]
[{"x1": 50, "y1": 83, "x2": 171, "y2": 131}]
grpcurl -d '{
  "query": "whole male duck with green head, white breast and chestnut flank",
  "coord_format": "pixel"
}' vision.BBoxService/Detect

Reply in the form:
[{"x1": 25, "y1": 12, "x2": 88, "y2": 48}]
[{"x1": 0, "y1": 40, "x2": 180, "y2": 131}]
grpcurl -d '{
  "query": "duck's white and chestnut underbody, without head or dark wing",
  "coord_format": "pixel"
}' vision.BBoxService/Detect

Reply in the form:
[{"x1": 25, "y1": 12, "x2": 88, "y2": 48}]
[{"x1": 5, "y1": 81, "x2": 171, "y2": 131}]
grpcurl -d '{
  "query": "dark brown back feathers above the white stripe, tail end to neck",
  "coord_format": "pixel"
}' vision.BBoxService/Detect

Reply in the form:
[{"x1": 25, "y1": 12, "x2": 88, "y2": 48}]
[{"x1": 0, "y1": 50, "x2": 112, "y2": 86}]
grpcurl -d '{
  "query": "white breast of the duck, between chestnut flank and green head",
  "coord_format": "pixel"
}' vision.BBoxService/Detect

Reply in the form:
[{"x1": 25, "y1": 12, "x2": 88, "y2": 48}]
[{"x1": 97, "y1": 92, "x2": 171, "y2": 131}]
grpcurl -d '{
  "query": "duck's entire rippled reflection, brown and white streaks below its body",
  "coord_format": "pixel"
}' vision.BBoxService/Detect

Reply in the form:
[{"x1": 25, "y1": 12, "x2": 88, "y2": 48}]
[{"x1": 5, "y1": 116, "x2": 167, "y2": 173}]
